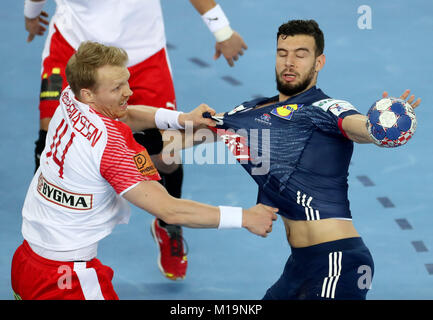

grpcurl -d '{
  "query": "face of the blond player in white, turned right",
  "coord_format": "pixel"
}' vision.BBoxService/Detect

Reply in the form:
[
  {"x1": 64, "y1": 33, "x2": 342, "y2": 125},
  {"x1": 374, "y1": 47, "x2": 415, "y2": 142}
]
[{"x1": 91, "y1": 65, "x2": 132, "y2": 119}]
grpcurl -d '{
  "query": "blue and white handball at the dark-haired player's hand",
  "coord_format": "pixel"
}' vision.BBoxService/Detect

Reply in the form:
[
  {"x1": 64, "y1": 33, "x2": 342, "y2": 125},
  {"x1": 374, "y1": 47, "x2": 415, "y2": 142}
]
[{"x1": 367, "y1": 97, "x2": 416, "y2": 148}]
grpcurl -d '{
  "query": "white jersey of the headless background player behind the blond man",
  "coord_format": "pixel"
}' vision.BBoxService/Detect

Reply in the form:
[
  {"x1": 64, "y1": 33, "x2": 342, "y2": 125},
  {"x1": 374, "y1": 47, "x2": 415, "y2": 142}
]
[{"x1": 52, "y1": 0, "x2": 166, "y2": 67}]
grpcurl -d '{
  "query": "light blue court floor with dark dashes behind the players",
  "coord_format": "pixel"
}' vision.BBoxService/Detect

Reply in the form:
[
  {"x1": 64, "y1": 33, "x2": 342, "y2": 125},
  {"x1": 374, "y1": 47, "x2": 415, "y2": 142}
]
[{"x1": 0, "y1": 0, "x2": 433, "y2": 300}]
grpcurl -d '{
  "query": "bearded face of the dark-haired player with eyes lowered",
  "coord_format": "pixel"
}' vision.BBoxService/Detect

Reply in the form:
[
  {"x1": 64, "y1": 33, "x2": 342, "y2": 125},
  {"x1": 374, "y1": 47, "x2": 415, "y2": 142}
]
[{"x1": 275, "y1": 35, "x2": 325, "y2": 100}]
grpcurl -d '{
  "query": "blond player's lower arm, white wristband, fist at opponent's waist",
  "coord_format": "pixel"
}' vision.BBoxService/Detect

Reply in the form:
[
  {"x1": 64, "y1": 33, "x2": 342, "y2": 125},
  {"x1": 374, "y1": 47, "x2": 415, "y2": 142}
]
[{"x1": 123, "y1": 181, "x2": 278, "y2": 237}]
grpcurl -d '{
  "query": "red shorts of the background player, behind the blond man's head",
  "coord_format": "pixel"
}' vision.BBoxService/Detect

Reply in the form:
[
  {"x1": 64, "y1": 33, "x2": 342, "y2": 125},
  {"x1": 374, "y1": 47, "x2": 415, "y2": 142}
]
[{"x1": 39, "y1": 28, "x2": 176, "y2": 119}]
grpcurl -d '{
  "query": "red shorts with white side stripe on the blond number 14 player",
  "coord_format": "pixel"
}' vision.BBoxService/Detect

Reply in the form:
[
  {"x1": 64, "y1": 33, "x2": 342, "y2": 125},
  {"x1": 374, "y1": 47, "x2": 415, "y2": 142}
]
[{"x1": 11, "y1": 241, "x2": 119, "y2": 300}]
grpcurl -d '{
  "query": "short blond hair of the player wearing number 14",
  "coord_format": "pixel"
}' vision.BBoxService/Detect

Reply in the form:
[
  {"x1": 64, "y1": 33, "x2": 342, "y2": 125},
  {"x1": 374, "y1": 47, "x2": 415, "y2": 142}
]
[{"x1": 65, "y1": 41, "x2": 128, "y2": 98}]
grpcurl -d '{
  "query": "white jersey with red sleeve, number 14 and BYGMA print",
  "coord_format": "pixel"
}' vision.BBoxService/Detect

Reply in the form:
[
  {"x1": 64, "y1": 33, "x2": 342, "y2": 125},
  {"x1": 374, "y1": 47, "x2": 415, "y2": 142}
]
[{"x1": 22, "y1": 87, "x2": 160, "y2": 251}]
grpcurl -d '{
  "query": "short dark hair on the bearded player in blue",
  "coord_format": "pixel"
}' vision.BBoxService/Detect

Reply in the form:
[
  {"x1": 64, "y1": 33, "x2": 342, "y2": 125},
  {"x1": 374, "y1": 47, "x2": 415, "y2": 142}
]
[{"x1": 277, "y1": 20, "x2": 325, "y2": 57}]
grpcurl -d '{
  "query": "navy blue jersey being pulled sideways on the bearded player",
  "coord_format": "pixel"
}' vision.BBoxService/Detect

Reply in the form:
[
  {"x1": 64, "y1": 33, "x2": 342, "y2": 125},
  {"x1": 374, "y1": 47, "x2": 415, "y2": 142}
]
[{"x1": 217, "y1": 87, "x2": 359, "y2": 220}]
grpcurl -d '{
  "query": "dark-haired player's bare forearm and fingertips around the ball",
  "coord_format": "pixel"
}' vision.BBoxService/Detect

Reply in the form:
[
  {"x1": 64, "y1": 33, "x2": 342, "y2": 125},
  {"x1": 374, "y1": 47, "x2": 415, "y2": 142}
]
[{"x1": 342, "y1": 90, "x2": 421, "y2": 143}]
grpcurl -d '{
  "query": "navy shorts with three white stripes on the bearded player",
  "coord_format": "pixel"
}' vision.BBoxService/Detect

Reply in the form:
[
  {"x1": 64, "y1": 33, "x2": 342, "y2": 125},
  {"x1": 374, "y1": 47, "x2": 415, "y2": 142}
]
[{"x1": 263, "y1": 237, "x2": 374, "y2": 300}]
